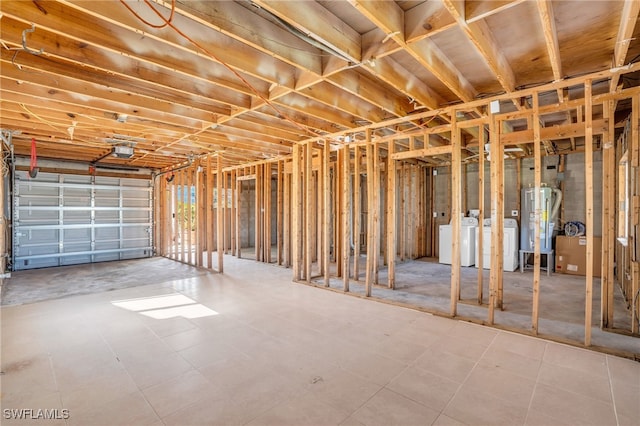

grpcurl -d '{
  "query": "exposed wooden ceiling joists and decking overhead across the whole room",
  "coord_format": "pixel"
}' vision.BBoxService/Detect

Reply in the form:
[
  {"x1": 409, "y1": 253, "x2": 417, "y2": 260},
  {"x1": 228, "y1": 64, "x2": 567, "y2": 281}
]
[{"x1": 0, "y1": 0, "x2": 640, "y2": 168}]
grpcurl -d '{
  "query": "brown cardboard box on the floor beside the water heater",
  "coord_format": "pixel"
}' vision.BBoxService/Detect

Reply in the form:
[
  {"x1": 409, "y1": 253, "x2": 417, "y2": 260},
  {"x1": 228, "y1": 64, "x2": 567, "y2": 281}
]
[{"x1": 556, "y1": 235, "x2": 602, "y2": 277}]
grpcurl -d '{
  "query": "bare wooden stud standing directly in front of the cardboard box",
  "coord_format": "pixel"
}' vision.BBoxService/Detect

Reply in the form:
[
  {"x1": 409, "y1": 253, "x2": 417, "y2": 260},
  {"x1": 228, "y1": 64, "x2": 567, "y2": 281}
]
[{"x1": 584, "y1": 79, "x2": 593, "y2": 346}]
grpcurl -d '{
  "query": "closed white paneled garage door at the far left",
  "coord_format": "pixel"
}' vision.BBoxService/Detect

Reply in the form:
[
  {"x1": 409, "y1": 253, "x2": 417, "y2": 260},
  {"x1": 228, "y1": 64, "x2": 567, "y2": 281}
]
[{"x1": 12, "y1": 172, "x2": 152, "y2": 270}]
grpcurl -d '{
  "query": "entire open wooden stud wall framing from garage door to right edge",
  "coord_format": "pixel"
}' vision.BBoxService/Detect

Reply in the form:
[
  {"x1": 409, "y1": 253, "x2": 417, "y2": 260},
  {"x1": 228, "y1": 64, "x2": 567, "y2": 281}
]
[{"x1": 152, "y1": 75, "x2": 640, "y2": 346}]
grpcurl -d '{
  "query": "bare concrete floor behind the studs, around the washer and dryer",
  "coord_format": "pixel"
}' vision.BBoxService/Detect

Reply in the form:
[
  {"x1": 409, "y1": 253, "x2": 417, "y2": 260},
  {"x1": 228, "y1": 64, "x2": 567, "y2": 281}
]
[{"x1": 312, "y1": 256, "x2": 640, "y2": 359}]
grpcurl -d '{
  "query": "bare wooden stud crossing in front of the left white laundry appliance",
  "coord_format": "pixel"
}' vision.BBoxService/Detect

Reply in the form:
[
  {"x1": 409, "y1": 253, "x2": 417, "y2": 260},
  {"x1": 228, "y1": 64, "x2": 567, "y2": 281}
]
[{"x1": 450, "y1": 111, "x2": 462, "y2": 316}]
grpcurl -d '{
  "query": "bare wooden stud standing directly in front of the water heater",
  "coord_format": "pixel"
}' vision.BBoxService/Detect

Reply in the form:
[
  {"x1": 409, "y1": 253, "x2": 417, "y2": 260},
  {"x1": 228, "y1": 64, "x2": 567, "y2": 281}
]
[{"x1": 531, "y1": 92, "x2": 540, "y2": 334}]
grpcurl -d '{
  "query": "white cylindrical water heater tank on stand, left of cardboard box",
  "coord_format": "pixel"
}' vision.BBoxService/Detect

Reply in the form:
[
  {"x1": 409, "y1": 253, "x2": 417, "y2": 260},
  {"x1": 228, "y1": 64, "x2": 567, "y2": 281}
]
[{"x1": 520, "y1": 186, "x2": 562, "y2": 253}]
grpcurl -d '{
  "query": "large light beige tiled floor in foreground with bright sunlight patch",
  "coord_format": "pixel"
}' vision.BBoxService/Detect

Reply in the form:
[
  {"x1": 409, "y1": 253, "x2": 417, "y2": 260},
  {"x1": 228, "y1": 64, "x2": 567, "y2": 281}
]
[{"x1": 0, "y1": 256, "x2": 640, "y2": 425}]
